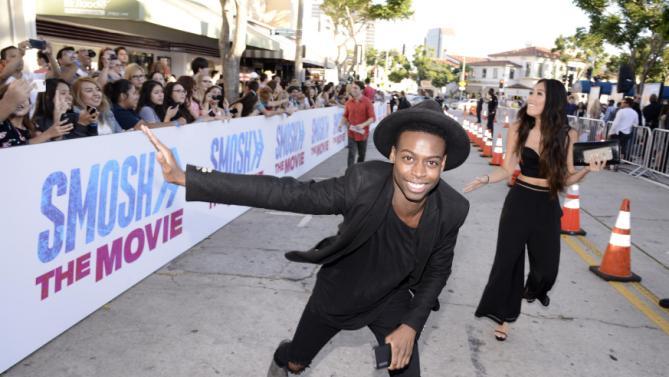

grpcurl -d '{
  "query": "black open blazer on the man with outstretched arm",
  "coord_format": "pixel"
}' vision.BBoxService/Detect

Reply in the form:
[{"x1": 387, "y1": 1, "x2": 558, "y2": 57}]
[{"x1": 186, "y1": 161, "x2": 469, "y2": 331}]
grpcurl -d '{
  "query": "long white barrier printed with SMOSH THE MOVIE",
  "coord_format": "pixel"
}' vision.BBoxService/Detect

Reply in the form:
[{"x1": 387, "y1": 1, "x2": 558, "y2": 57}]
[{"x1": 0, "y1": 103, "x2": 385, "y2": 372}]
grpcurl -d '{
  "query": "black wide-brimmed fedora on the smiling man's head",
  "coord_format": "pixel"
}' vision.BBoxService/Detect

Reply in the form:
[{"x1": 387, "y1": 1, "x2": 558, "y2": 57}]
[{"x1": 374, "y1": 99, "x2": 470, "y2": 170}]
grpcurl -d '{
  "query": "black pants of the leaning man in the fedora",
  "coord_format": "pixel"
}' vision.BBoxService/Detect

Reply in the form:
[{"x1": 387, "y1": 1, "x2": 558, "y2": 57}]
[{"x1": 274, "y1": 290, "x2": 420, "y2": 377}]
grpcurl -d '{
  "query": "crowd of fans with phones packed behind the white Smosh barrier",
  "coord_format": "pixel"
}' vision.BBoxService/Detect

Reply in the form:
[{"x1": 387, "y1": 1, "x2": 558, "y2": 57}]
[{"x1": 0, "y1": 40, "x2": 383, "y2": 148}]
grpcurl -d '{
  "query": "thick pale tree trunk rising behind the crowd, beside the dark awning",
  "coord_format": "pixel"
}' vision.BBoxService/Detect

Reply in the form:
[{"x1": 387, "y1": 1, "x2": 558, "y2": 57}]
[{"x1": 218, "y1": 0, "x2": 248, "y2": 102}]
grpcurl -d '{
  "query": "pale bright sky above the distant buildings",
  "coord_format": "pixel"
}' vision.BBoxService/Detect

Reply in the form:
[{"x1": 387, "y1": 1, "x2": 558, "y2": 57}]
[{"x1": 376, "y1": 0, "x2": 590, "y2": 57}]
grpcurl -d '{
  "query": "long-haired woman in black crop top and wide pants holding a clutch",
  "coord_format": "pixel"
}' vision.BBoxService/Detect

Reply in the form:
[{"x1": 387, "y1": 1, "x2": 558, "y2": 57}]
[{"x1": 464, "y1": 79, "x2": 605, "y2": 341}]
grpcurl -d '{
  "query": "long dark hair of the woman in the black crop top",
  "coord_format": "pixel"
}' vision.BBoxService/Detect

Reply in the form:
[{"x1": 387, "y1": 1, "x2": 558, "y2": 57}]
[{"x1": 514, "y1": 79, "x2": 569, "y2": 196}]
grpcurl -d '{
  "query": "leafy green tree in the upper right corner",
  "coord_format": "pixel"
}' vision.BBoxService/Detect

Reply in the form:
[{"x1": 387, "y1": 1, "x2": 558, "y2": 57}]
[{"x1": 574, "y1": 0, "x2": 669, "y2": 92}]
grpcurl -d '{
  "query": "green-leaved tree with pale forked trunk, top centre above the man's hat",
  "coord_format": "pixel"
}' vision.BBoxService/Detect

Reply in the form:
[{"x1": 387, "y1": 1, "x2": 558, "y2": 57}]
[{"x1": 321, "y1": 0, "x2": 413, "y2": 78}]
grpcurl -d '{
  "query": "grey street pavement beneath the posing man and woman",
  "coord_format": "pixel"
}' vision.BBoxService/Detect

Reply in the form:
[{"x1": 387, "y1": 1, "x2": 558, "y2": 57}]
[{"x1": 2, "y1": 115, "x2": 669, "y2": 377}]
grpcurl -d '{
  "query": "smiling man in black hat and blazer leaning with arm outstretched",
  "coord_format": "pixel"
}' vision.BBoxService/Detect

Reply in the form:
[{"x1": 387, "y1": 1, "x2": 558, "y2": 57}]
[{"x1": 143, "y1": 100, "x2": 470, "y2": 376}]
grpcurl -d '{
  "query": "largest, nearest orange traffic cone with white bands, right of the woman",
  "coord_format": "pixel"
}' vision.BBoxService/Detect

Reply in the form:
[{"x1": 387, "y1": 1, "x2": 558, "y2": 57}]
[{"x1": 590, "y1": 199, "x2": 641, "y2": 282}]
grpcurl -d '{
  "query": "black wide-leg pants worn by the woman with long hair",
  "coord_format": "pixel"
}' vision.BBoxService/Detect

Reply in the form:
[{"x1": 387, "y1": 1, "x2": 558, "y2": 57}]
[{"x1": 476, "y1": 180, "x2": 562, "y2": 324}]
